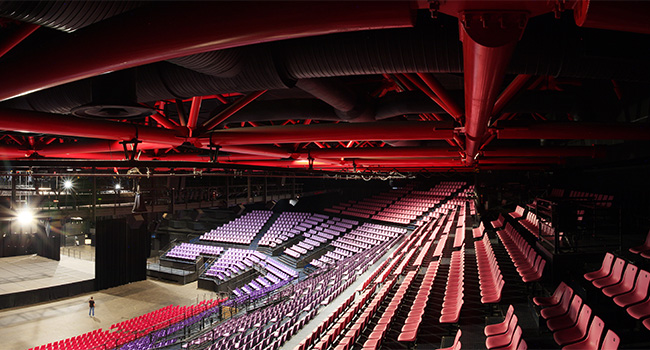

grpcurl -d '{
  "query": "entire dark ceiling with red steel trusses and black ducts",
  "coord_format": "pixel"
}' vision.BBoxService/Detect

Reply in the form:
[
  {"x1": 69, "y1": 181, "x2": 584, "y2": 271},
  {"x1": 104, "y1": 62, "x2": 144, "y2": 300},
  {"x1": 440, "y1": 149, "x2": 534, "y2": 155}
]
[{"x1": 0, "y1": 0, "x2": 650, "y2": 173}]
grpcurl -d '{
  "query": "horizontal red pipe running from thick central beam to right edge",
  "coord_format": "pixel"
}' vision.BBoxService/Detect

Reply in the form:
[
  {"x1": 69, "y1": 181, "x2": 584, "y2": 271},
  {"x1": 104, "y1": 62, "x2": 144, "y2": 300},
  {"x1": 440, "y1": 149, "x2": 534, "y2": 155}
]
[{"x1": 497, "y1": 122, "x2": 650, "y2": 140}]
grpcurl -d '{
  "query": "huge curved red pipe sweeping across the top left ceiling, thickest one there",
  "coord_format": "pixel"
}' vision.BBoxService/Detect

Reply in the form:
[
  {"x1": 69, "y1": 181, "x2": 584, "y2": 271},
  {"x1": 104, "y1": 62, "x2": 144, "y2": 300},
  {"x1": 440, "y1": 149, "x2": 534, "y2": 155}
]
[{"x1": 0, "y1": 1, "x2": 413, "y2": 100}]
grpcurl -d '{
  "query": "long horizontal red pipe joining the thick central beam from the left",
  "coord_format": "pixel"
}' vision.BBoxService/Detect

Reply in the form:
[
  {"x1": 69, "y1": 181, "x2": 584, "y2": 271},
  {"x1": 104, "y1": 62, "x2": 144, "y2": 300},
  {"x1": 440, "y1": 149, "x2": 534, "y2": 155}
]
[{"x1": 210, "y1": 122, "x2": 454, "y2": 145}]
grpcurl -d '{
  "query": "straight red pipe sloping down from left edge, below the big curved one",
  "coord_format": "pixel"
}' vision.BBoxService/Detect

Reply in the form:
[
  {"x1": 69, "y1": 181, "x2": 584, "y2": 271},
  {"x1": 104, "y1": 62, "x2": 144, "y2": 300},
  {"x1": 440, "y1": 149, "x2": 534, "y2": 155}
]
[{"x1": 0, "y1": 109, "x2": 186, "y2": 146}]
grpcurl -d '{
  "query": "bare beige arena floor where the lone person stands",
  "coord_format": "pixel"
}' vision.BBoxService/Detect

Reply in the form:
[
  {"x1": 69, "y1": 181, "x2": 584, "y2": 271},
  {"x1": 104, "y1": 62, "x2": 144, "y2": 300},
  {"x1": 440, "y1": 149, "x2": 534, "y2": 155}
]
[{"x1": 0, "y1": 280, "x2": 216, "y2": 350}]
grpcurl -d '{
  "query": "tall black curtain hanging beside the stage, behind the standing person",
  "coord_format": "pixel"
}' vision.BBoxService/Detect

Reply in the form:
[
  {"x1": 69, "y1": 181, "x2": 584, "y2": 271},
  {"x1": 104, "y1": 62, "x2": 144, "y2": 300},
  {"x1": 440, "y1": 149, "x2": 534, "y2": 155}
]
[{"x1": 95, "y1": 215, "x2": 150, "y2": 290}]
